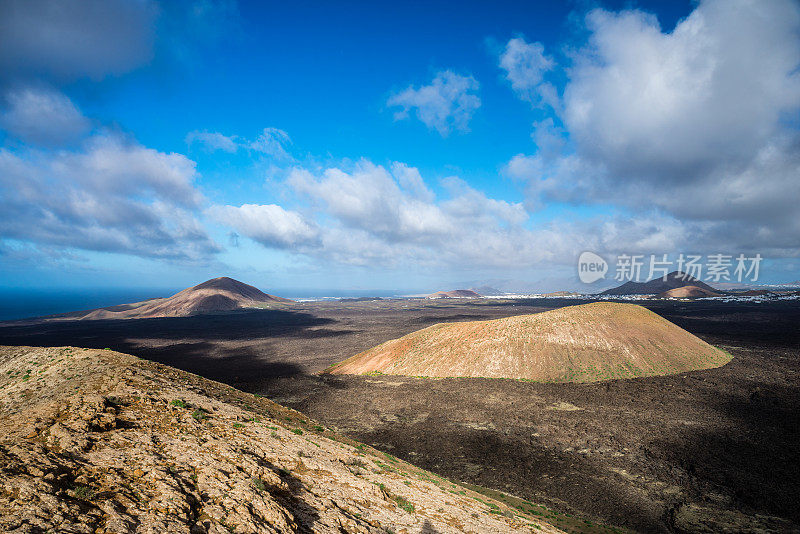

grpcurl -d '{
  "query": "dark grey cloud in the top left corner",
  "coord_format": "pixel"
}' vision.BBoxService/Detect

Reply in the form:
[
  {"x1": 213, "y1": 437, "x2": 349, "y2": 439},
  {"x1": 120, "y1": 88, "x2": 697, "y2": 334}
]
[{"x1": 0, "y1": 0, "x2": 158, "y2": 80}]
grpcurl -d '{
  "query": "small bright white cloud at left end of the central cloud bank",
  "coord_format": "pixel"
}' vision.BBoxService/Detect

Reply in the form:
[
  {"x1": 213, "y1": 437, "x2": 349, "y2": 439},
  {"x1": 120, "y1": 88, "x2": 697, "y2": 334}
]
[{"x1": 208, "y1": 204, "x2": 319, "y2": 248}]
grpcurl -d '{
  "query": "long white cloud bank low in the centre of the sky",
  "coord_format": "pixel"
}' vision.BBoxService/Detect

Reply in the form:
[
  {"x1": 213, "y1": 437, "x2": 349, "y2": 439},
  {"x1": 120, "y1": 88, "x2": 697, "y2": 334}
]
[{"x1": 209, "y1": 160, "x2": 620, "y2": 268}]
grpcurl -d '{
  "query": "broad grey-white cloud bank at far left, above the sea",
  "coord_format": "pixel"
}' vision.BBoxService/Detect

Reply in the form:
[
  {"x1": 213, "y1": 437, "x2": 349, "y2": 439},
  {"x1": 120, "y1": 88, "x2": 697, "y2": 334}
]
[{"x1": 0, "y1": 133, "x2": 219, "y2": 260}]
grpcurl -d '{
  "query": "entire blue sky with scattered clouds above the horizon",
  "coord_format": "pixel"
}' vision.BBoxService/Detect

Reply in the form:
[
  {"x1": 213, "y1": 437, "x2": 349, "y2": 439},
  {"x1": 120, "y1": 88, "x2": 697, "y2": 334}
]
[{"x1": 0, "y1": 0, "x2": 800, "y2": 291}]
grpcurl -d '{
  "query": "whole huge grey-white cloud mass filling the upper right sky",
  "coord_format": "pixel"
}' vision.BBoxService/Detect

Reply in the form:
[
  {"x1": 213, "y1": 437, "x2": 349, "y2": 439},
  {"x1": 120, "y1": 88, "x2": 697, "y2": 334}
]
[{"x1": 506, "y1": 0, "x2": 800, "y2": 255}]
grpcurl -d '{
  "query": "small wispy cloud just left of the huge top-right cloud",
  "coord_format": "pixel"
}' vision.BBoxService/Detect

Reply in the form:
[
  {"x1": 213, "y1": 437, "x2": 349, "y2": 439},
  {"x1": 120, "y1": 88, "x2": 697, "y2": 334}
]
[{"x1": 500, "y1": 37, "x2": 555, "y2": 102}]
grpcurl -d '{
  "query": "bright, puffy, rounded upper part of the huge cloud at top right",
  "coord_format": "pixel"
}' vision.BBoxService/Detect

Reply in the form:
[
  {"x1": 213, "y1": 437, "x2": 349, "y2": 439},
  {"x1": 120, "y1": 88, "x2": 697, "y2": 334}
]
[{"x1": 564, "y1": 0, "x2": 800, "y2": 180}]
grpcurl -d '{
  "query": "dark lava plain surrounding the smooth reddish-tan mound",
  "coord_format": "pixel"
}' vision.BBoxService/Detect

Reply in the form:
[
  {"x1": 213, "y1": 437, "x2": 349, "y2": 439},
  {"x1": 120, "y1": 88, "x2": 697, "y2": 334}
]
[{"x1": 0, "y1": 299, "x2": 800, "y2": 532}]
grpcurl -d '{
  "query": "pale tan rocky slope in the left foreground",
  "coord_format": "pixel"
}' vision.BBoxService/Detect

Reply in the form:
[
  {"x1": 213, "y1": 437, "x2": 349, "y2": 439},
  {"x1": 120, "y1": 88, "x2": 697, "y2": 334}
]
[{"x1": 0, "y1": 347, "x2": 559, "y2": 534}]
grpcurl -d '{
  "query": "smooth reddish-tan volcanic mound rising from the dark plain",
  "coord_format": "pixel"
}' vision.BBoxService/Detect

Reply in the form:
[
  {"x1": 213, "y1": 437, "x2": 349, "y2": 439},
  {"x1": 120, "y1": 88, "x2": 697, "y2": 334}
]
[{"x1": 326, "y1": 302, "x2": 731, "y2": 382}]
